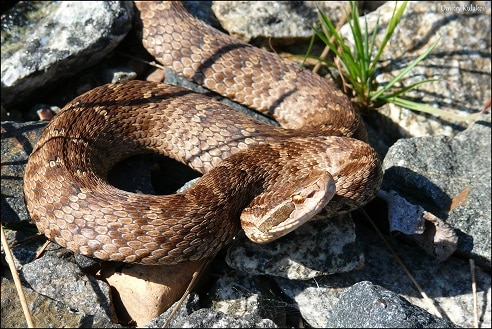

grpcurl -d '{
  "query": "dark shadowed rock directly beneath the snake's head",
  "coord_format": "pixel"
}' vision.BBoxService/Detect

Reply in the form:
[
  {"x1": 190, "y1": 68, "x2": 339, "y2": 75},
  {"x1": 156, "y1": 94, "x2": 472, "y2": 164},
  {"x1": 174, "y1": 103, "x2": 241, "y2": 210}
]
[{"x1": 226, "y1": 215, "x2": 364, "y2": 280}]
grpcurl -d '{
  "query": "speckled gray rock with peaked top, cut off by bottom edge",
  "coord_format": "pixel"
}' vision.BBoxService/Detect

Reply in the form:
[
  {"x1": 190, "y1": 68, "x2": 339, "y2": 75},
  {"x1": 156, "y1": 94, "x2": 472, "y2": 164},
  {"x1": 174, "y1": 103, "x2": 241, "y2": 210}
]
[{"x1": 327, "y1": 281, "x2": 456, "y2": 328}]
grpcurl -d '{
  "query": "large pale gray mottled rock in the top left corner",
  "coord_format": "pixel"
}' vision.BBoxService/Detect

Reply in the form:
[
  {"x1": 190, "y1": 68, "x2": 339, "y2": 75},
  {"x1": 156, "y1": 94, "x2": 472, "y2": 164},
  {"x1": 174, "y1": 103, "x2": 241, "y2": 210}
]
[{"x1": 1, "y1": 1, "x2": 133, "y2": 106}]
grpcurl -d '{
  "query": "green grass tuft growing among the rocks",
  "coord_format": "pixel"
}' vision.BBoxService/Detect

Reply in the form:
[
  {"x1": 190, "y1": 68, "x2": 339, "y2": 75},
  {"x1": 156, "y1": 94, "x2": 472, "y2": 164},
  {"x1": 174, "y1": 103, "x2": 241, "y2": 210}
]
[{"x1": 305, "y1": 1, "x2": 478, "y2": 121}]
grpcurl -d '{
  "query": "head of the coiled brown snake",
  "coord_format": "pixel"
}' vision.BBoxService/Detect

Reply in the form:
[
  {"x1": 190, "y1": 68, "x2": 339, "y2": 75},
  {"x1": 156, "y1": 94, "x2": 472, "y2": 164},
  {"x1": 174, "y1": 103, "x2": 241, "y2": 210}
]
[{"x1": 241, "y1": 170, "x2": 335, "y2": 244}]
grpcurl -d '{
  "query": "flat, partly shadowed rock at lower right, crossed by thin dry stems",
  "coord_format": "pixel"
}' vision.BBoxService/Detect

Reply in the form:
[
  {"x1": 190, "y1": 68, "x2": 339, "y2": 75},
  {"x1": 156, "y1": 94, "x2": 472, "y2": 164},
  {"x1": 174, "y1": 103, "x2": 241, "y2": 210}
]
[{"x1": 273, "y1": 219, "x2": 491, "y2": 328}]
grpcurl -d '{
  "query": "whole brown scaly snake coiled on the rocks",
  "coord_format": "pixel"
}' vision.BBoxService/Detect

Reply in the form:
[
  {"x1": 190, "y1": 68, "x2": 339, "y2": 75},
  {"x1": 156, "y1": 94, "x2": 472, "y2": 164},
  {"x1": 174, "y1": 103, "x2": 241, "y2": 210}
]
[{"x1": 24, "y1": 2, "x2": 382, "y2": 265}]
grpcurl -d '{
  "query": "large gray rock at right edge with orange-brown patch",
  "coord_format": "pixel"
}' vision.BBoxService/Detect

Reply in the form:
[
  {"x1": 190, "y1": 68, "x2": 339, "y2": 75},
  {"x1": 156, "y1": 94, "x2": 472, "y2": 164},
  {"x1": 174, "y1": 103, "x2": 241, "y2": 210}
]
[{"x1": 383, "y1": 115, "x2": 491, "y2": 267}]
